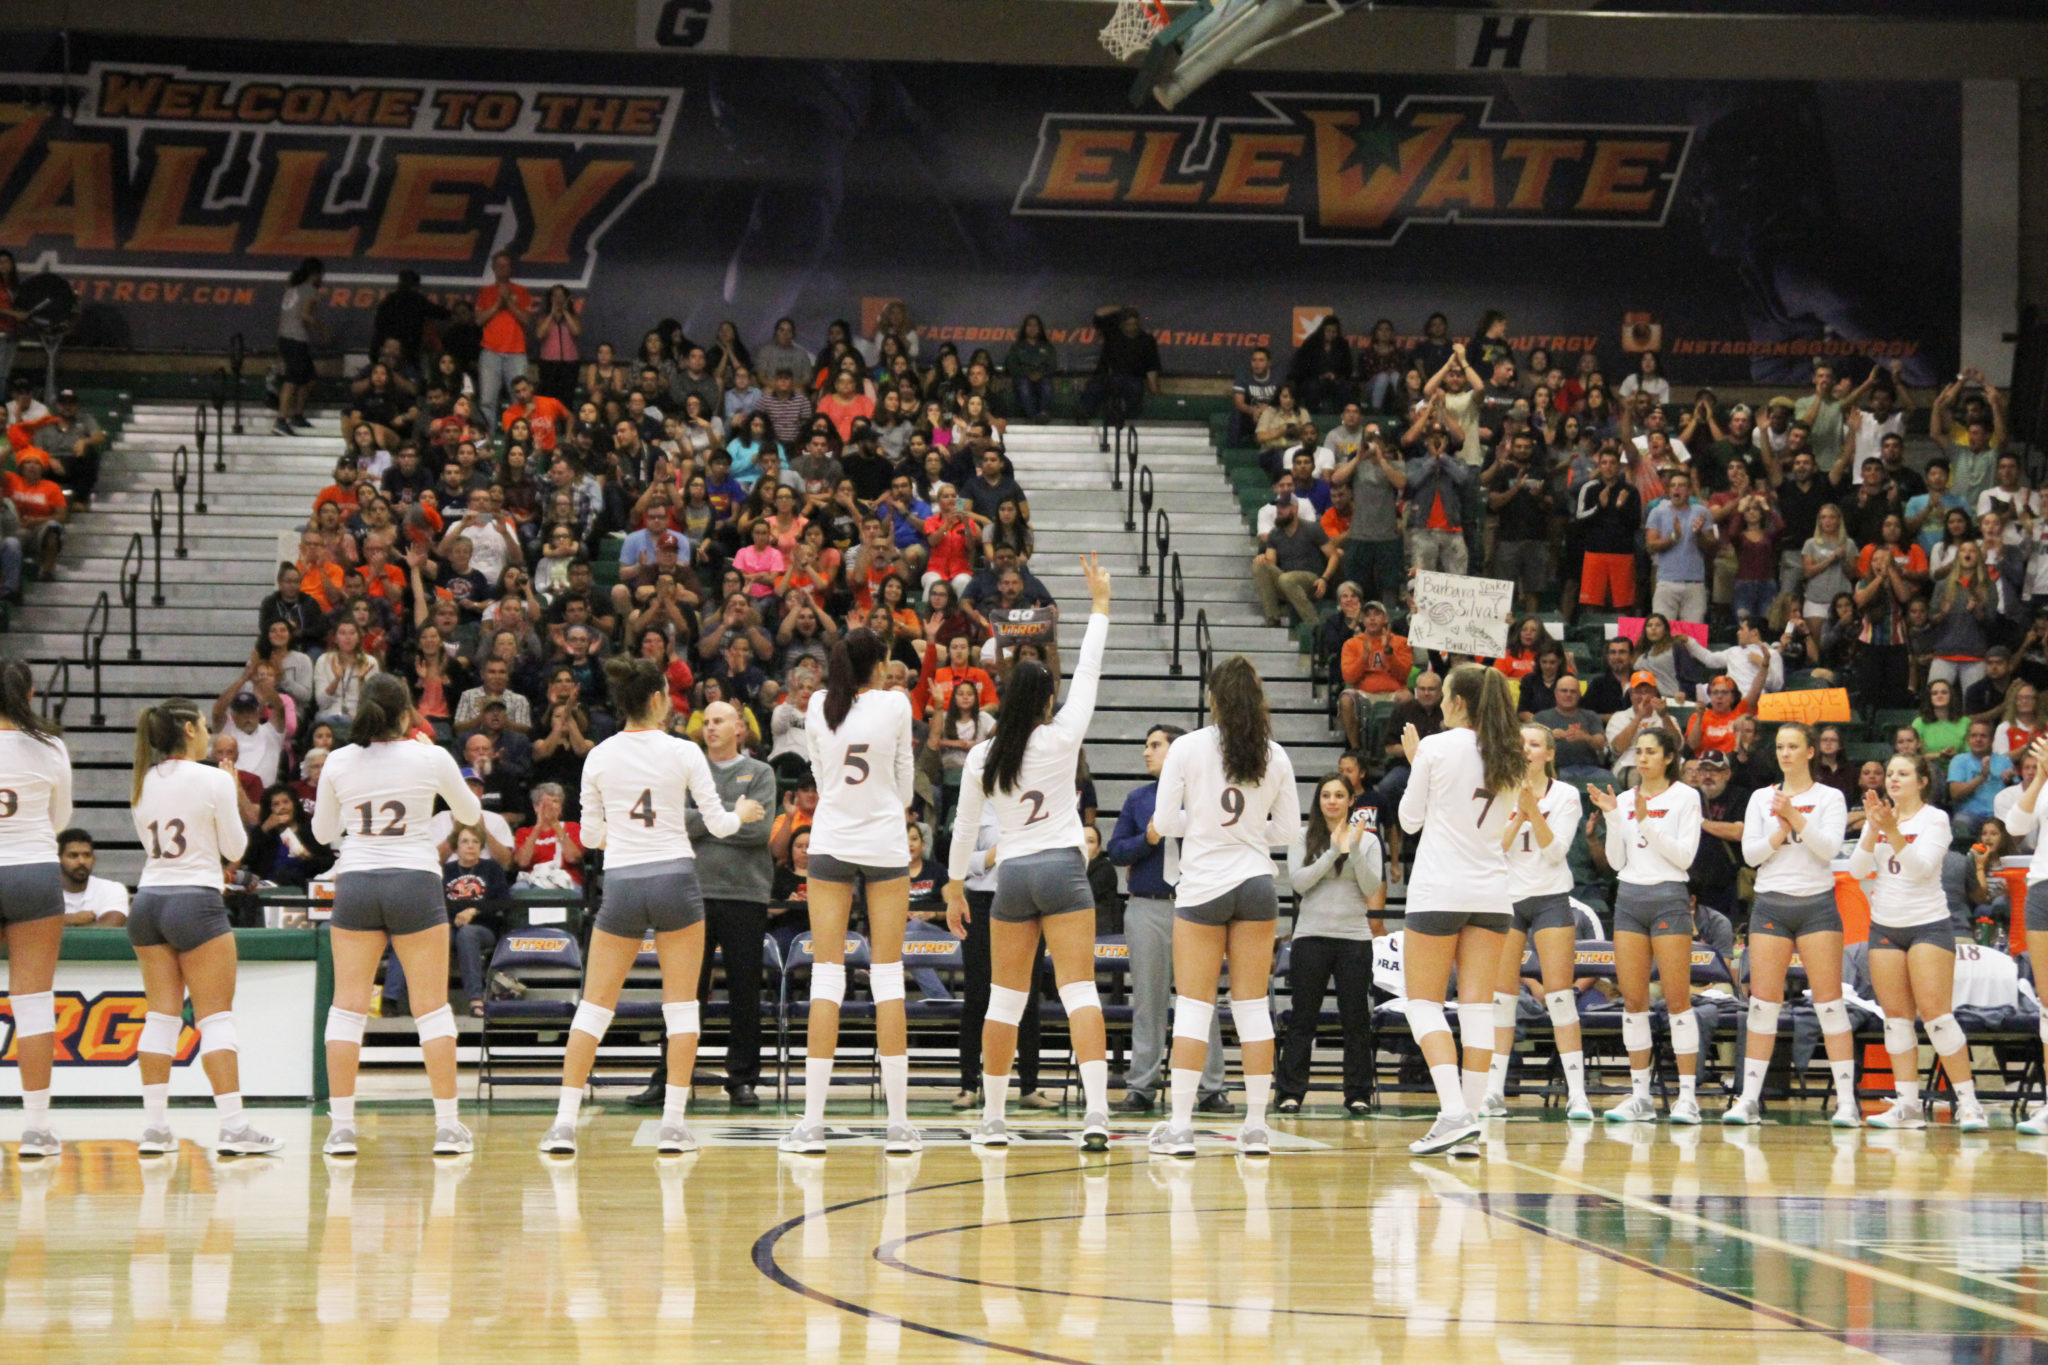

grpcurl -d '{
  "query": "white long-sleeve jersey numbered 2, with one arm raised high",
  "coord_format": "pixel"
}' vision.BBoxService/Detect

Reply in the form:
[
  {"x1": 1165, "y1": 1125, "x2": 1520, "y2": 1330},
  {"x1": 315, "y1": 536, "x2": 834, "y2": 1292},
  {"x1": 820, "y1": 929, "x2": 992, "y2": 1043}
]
[{"x1": 946, "y1": 616, "x2": 1110, "y2": 882}]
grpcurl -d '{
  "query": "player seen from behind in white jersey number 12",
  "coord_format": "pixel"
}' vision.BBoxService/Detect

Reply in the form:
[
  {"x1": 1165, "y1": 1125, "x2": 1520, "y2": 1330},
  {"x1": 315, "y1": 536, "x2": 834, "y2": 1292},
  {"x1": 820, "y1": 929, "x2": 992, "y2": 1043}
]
[{"x1": 313, "y1": 673, "x2": 483, "y2": 1156}]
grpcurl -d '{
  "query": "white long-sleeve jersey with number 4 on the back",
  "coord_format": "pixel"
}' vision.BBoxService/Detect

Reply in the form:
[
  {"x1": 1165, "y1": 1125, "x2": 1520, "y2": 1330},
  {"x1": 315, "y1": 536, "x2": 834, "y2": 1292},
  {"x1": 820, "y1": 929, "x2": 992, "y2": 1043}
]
[{"x1": 580, "y1": 731, "x2": 739, "y2": 868}]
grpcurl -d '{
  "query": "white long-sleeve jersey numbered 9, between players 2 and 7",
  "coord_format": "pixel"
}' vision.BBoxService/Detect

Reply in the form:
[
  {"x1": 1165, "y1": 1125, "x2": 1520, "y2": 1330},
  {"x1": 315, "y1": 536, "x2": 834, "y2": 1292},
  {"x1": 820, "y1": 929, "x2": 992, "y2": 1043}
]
[{"x1": 1153, "y1": 724, "x2": 1294, "y2": 905}]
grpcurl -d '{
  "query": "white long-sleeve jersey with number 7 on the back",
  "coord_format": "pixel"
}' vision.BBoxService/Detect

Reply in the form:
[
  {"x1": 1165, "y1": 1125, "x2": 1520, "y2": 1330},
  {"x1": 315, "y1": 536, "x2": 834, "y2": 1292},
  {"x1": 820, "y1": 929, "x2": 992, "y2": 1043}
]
[{"x1": 1401, "y1": 729, "x2": 1516, "y2": 915}]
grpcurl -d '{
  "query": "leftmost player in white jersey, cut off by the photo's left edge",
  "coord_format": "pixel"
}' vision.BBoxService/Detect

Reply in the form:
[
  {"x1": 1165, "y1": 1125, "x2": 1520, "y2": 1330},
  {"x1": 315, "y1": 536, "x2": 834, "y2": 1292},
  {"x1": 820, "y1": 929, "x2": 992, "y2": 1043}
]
[{"x1": 0, "y1": 659, "x2": 72, "y2": 1158}]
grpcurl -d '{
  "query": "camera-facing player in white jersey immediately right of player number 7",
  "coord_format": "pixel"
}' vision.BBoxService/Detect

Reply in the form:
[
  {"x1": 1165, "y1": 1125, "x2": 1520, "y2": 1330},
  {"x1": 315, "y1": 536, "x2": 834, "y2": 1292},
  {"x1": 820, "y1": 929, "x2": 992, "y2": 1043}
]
[{"x1": 1481, "y1": 724, "x2": 1593, "y2": 1121}]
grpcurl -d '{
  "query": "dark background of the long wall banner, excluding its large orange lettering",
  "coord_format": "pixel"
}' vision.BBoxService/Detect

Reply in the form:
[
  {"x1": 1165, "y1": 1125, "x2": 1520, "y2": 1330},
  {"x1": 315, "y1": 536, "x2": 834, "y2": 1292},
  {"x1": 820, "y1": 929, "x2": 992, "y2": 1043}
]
[{"x1": 0, "y1": 39, "x2": 1960, "y2": 389}]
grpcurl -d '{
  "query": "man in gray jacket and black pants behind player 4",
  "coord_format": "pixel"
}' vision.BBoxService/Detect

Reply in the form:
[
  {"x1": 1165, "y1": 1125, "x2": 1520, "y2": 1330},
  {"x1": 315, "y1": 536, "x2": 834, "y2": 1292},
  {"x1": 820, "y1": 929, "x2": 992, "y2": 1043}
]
[{"x1": 684, "y1": 702, "x2": 776, "y2": 1109}]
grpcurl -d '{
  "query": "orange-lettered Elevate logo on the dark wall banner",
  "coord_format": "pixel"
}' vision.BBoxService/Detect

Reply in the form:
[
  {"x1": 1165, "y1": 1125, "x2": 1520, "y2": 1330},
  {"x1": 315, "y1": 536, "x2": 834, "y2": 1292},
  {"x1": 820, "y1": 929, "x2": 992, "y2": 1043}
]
[{"x1": 1012, "y1": 92, "x2": 1692, "y2": 246}]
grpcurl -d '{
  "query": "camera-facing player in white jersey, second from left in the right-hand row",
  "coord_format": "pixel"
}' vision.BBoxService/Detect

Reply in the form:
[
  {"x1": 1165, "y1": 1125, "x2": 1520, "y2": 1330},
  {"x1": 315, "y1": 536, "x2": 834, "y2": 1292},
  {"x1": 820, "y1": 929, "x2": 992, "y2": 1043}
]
[{"x1": 1587, "y1": 731, "x2": 1702, "y2": 1124}]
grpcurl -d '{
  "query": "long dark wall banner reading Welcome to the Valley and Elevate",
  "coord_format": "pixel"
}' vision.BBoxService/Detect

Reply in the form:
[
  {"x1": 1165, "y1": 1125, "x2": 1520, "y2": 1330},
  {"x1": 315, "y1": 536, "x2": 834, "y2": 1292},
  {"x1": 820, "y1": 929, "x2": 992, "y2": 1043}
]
[{"x1": 0, "y1": 37, "x2": 1962, "y2": 384}]
